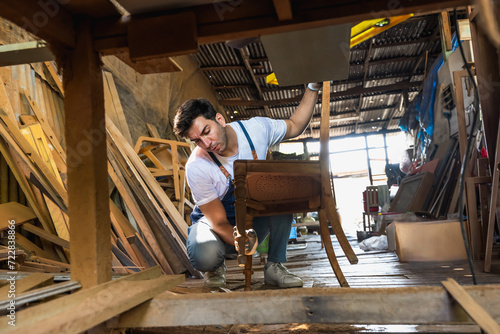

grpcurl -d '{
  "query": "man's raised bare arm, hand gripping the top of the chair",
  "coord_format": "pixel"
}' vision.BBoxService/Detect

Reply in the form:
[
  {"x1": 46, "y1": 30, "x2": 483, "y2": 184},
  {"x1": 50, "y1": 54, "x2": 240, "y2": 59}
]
[{"x1": 283, "y1": 83, "x2": 321, "y2": 140}]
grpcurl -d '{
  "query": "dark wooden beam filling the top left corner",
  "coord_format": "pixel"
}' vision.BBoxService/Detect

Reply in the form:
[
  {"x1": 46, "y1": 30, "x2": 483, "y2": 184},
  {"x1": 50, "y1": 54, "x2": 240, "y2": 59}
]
[{"x1": 0, "y1": 0, "x2": 75, "y2": 48}]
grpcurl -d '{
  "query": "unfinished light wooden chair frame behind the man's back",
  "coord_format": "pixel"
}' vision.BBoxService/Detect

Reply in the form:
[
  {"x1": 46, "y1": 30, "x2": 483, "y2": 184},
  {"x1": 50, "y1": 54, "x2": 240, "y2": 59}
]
[{"x1": 134, "y1": 137, "x2": 194, "y2": 216}]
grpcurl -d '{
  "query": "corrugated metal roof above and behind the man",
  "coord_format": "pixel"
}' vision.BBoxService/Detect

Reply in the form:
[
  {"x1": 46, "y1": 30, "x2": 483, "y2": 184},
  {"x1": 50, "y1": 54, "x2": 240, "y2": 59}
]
[{"x1": 195, "y1": 15, "x2": 441, "y2": 139}]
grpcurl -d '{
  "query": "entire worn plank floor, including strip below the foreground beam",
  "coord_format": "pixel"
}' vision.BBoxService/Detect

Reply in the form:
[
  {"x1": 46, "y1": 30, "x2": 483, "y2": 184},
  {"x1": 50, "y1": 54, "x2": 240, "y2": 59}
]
[{"x1": 146, "y1": 235, "x2": 500, "y2": 334}]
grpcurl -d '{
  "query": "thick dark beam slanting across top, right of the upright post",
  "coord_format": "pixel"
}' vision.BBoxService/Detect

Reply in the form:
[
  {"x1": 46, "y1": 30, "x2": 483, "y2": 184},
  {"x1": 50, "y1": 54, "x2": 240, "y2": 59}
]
[{"x1": 93, "y1": 0, "x2": 471, "y2": 54}]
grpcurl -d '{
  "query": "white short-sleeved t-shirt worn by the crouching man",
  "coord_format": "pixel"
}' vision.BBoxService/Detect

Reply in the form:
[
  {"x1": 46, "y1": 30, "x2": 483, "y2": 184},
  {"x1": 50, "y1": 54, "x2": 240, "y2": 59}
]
[{"x1": 186, "y1": 117, "x2": 286, "y2": 205}]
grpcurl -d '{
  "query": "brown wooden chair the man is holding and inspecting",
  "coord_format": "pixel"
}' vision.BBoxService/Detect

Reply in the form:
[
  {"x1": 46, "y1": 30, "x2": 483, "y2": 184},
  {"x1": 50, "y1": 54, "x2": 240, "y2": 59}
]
[{"x1": 234, "y1": 82, "x2": 358, "y2": 290}]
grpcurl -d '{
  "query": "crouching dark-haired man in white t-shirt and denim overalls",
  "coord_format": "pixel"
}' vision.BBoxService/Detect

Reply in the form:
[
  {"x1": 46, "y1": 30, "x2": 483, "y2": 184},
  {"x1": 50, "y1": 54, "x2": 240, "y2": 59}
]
[{"x1": 174, "y1": 83, "x2": 321, "y2": 288}]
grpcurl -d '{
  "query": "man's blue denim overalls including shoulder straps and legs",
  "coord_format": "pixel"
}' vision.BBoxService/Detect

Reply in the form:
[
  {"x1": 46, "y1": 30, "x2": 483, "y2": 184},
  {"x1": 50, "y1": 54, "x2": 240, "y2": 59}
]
[{"x1": 186, "y1": 122, "x2": 292, "y2": 271}]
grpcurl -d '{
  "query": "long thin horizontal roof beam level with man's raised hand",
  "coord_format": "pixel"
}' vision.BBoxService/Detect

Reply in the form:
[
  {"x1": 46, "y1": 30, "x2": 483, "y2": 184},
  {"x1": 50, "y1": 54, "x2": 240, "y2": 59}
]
[{"x1": 219, "y1": 81, "x2": 422, "y2": 107}]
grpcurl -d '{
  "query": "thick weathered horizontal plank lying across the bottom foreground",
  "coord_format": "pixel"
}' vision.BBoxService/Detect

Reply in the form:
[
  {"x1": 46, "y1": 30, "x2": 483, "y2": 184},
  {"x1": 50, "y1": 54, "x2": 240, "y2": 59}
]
[{"x1": 113, "y1": 285, "x2": 500, "y2": 328}]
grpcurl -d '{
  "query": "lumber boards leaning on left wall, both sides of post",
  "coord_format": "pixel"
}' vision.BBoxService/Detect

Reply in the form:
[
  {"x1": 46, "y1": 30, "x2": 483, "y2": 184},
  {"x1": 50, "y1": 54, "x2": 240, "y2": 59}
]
[{"x1": 0, "y1": 63, "x2": 200, "y2": 276}]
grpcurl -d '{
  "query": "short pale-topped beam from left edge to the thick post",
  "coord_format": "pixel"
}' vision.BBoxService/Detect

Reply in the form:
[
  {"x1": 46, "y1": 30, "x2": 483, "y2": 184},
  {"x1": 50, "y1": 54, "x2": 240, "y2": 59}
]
[{"x1": 0, "y1": 41, "x2": 54, "y2": 66}]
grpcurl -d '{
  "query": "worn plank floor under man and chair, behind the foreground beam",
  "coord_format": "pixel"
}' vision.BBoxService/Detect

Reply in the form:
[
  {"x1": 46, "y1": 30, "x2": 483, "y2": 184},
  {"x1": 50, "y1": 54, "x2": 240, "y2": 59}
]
[{"x1": 177, "y1": 235, "x2": 500, "y2": 293}]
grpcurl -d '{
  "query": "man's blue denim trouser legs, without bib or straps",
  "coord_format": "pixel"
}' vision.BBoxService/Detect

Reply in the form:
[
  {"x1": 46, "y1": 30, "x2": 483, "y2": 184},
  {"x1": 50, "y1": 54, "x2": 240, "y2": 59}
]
[{"x1": 186, "y1": 214, "x2": 293, "y2": 271}]
